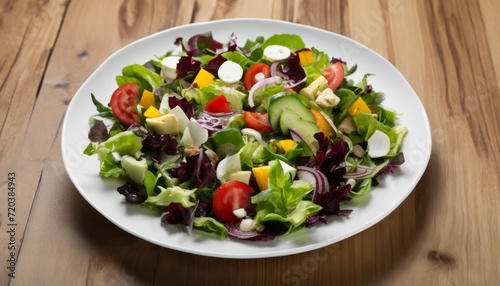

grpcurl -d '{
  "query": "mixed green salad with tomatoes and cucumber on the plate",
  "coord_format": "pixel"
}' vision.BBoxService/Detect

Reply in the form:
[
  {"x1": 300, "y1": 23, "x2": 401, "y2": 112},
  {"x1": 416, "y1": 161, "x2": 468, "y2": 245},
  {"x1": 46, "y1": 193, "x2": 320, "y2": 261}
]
[{"x1": 84, "y1": 32, "x2": 408, "y2": 240}]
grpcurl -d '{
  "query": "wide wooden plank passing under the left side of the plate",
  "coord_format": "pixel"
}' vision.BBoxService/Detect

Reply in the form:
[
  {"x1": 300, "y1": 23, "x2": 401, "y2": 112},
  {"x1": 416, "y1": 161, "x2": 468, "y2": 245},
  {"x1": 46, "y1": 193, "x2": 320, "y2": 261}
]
[{"x1": 8, "y1": 1, "x2": 186, "y2": 285}]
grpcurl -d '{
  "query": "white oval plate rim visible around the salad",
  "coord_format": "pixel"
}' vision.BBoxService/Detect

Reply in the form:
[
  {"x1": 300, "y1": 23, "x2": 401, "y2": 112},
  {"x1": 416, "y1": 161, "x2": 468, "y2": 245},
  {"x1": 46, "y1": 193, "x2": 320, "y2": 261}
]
[{"x1": 62, "y1": 19, "x2": 431, "y2": 258}]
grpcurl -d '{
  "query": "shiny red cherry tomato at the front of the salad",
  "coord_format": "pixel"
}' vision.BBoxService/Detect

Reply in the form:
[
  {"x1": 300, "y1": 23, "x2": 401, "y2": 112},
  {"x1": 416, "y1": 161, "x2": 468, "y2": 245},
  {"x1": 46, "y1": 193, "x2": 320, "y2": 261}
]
[{"x1": 212, "y1": 181, "x2": 253, "y2": 223}]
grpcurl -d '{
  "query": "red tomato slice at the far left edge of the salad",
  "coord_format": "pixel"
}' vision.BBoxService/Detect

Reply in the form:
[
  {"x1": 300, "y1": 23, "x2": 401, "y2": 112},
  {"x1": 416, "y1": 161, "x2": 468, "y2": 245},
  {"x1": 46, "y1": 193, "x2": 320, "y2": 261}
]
[{"x1": 109, "y1": 82, "x2": 141, "y2": 125}]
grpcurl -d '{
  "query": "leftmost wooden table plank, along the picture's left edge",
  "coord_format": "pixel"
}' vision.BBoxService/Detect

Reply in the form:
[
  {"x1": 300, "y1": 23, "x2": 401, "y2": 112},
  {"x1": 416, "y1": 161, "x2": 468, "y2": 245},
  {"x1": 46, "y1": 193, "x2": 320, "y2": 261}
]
[{"x1": 0, "y1": 1, "x2": 66, "y2": 285}]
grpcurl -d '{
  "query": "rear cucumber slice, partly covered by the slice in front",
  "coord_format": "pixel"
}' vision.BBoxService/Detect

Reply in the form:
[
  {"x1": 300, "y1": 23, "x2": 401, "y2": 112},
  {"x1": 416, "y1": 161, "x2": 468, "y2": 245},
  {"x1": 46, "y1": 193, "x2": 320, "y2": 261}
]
[{"x1": 268, "y1": 92, "x2": 314, "y2": 129}]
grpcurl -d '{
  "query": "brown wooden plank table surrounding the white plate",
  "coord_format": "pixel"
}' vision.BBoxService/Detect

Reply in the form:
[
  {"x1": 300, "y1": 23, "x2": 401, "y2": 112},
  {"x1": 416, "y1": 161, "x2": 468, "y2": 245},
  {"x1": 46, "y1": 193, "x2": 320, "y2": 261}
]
[{"x1": 0, "y1": 0, "x2": 500, "y2": 285}]
